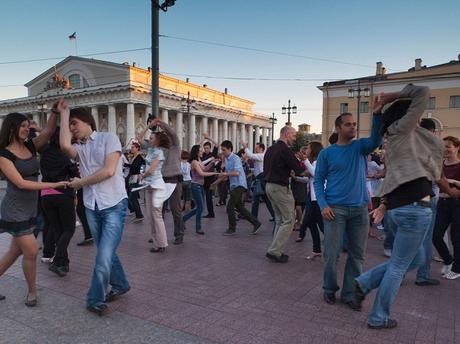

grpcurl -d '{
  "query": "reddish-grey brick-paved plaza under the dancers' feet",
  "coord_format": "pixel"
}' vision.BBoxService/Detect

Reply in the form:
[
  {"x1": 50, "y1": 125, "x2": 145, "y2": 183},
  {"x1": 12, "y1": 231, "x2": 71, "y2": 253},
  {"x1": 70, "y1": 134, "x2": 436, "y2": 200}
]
[{"x1": 0, "y1": 192, "x2": 460, "y2": 344}]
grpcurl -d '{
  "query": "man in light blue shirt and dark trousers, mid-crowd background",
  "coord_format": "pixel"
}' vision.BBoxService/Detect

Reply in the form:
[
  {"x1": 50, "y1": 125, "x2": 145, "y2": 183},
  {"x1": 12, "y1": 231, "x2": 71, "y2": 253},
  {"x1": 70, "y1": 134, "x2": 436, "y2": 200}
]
[{"x1": 220, "y1": 140, "x2": 261, "y2": 235}]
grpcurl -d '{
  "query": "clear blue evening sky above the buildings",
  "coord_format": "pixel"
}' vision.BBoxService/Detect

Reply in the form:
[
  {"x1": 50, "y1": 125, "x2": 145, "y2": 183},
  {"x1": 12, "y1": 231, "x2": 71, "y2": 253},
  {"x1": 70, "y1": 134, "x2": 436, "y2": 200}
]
[{"x1": 0, "y1": 0, "x2": 460, "y2": 136}]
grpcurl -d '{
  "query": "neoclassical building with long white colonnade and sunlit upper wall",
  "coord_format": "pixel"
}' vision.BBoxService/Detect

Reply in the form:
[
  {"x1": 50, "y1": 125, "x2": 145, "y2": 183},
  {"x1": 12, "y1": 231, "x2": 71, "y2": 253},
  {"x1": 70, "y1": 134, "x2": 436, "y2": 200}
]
[{"x1": 0, "y1": 56, "x2": 271, "y2": 150}]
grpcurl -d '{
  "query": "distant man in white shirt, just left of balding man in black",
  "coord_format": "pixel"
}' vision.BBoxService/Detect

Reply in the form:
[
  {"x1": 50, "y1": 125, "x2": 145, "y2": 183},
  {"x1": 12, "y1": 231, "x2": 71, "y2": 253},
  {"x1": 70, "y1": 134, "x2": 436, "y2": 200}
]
[{"x1": 241, "y1": 142, "x2": 275, "y2": 221}]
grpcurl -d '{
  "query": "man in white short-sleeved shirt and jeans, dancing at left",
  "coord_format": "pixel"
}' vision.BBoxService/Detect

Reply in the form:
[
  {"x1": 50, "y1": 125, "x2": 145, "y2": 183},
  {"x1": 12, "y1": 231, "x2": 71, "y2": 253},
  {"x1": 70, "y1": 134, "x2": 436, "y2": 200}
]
[{"x1": 58, "y1": 99, "x2": 130, "y2": 316}]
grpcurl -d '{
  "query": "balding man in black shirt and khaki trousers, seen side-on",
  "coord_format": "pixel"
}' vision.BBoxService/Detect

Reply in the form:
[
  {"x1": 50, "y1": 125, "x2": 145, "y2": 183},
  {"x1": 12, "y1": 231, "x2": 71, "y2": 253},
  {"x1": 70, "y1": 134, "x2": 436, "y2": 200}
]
[{"x1": 264, "y1": 126, "x2": 303, "y2": 263}]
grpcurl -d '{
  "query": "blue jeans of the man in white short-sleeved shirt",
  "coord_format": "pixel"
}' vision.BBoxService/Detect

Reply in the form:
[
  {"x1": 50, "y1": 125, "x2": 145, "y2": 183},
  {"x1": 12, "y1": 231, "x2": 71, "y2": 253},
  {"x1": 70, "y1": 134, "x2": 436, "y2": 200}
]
[{"x1": 86, "y1": 198, "x2": 129, "y2": 306}]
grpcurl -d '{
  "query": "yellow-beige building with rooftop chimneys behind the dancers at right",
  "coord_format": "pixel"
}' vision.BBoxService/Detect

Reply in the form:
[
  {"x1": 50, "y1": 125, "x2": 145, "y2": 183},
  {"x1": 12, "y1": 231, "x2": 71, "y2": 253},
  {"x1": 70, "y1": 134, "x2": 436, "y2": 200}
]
[{"x1": 318, "y1": 55, "x2": 460, "y2": 144}]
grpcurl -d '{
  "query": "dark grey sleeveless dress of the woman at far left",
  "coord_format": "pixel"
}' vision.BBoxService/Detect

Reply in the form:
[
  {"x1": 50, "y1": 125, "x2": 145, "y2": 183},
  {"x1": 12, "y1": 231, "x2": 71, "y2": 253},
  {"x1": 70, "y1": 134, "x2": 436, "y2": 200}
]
[{"x1": 0, "y1": 140, "x2": 40, "y2": 236}]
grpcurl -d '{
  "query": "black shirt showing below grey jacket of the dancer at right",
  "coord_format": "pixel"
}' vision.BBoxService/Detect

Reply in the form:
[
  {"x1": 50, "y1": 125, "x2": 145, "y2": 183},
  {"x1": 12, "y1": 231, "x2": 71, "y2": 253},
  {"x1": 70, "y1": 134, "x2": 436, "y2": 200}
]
[{"x1": 386, "y1": 177, "x2": 431, "y2": 209}]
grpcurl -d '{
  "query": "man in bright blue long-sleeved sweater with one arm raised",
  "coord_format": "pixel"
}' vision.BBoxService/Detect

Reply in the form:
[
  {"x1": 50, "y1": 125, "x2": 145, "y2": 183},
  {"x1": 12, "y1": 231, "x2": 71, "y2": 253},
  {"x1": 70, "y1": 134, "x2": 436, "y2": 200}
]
[{"x1": 314, "y1": 105, "x2": 383, "y2": 307}]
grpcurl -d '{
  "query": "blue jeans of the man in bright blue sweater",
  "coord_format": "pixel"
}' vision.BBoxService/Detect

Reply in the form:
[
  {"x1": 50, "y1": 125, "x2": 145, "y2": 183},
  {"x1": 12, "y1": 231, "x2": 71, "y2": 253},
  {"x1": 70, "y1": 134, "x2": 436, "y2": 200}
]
[{"x1": 323, "y1": 205, "x2": 369, "y2": 302}]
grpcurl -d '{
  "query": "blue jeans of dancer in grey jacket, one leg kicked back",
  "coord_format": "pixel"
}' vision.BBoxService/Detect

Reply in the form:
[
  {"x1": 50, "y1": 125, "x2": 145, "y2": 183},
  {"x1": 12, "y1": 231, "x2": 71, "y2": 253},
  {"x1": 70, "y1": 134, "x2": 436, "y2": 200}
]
[{"x1": 356, "y1": 205, "x2": 432, "y2": 325}]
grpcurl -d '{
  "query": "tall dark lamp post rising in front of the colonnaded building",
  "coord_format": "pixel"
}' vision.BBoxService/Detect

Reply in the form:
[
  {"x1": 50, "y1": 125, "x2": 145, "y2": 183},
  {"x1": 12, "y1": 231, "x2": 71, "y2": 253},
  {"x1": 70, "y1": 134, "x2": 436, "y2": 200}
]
[{"x1": 151, "y1": 0, "x2": 176, "y2": 118}]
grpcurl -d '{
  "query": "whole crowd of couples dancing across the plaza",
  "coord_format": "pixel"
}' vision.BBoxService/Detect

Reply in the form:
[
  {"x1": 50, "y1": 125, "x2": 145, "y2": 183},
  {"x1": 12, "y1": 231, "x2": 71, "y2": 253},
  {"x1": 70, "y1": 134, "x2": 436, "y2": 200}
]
[{"x1": 0, "y1": 85, "x2": 460, "y2": 329}]
